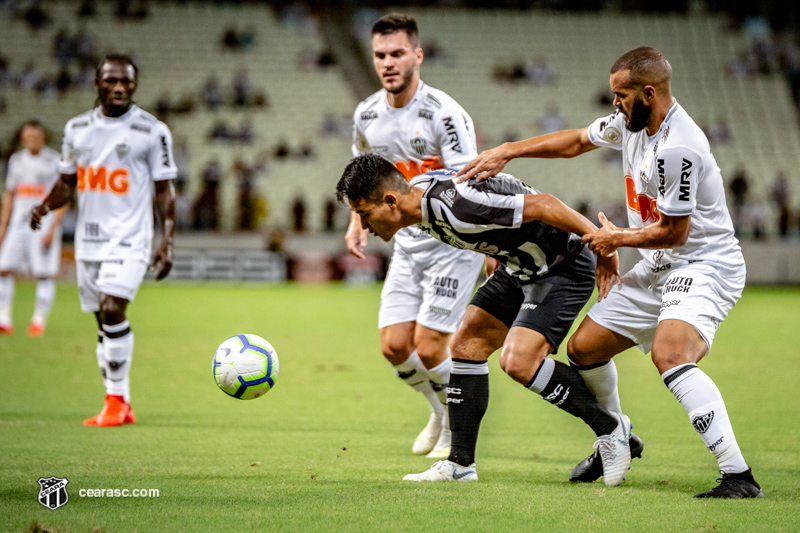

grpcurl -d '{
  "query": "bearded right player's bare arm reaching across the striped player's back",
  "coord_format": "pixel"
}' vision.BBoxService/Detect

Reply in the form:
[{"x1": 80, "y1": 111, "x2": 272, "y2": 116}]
[{"x1": 456, "y1": 127, "x2": 598, "y2": 183}]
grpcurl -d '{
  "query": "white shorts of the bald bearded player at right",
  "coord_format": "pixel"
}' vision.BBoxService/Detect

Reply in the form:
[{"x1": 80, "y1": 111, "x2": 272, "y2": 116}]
[{"x1": 589, "y1": 261, "x2": 746, "y2": 353}]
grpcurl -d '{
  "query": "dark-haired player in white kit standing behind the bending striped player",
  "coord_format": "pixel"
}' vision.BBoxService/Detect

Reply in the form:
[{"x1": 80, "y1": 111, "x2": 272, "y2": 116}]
[{"x1": 345, "y1": 13, "x2": 483, "y2": 458}]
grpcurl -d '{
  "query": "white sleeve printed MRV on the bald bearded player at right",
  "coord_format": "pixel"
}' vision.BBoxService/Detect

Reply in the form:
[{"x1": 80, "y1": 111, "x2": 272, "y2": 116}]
[{"x1": 655, "y1": 146, "x2": 702, "y2": 216}]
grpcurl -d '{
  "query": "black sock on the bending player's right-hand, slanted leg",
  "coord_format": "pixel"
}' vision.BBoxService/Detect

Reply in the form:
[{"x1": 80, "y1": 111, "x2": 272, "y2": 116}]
[{"x1": 528, "y1": 361, "x2": 619, "y2": 436}]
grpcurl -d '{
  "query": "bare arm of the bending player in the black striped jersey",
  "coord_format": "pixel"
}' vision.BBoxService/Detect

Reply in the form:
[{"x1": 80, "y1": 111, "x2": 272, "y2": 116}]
[{"x1": 522, "y1": 194, "x2": 620, "y2": 300}]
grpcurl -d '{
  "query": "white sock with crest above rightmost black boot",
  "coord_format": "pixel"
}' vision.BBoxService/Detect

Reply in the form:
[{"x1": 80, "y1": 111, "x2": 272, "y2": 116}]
[{"x1": 661, "y1": 363, "x2": 748, "y2": 474}]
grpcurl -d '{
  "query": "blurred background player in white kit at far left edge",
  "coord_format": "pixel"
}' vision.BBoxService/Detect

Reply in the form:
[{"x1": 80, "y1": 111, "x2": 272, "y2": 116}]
[{"x1": 0, "y1": 121, "x2": 67, "y2": 337}]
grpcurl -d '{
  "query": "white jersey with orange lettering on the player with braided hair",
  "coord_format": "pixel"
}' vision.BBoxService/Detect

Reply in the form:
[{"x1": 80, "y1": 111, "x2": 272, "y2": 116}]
[{"x1": 59, "y1": 105, "x2": 178, "y2": 261}]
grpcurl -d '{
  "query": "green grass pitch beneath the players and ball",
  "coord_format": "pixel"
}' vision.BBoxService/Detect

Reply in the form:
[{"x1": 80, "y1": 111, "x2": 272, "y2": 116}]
[{"x1": 0, "y1": 283, "x2": 800, "y2": 532}]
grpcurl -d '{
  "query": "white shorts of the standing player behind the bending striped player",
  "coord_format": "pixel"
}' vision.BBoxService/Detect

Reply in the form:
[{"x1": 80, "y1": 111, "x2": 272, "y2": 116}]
[{"x1": 378, "y1": 241, "x2": 484, "y2": 333}]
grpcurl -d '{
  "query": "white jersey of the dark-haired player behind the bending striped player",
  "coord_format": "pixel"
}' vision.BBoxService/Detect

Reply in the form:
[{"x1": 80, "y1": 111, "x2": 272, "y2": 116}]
[{"x1": 353, "y1": 80, "x2": 478, "y2": 252}]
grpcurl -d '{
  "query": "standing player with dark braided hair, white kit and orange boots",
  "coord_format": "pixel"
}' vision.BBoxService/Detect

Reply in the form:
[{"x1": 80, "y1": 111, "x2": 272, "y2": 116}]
[{"x1": 30, "y1": 54, "x2": 177, "y2": 426}]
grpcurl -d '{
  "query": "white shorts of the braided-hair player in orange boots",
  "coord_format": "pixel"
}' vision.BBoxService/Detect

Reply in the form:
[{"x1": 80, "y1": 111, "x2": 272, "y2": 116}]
[{"x1": 75, "y1": 259, "x2": 147, "y2": 313}]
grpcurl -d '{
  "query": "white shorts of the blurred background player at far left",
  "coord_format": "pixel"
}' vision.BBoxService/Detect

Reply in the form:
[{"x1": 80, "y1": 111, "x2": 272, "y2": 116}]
[{"x1": 0, "y1": 227, "x2": 61, "y2": 278}]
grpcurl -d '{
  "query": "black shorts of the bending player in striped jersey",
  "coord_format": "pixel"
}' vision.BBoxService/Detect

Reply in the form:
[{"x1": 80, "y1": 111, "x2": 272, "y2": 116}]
[{"x1": 470, "y1": 248, "x2": 595, "y2": 353}]
